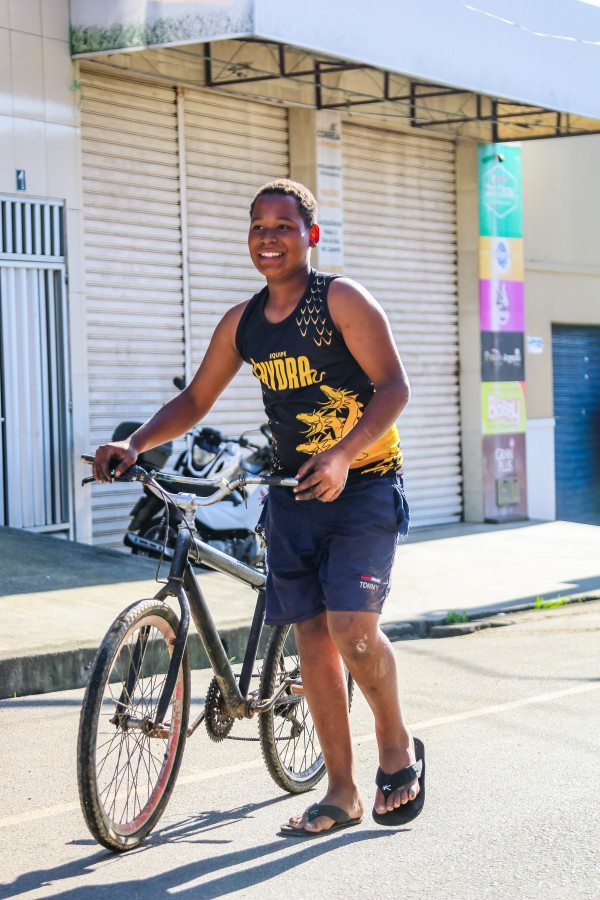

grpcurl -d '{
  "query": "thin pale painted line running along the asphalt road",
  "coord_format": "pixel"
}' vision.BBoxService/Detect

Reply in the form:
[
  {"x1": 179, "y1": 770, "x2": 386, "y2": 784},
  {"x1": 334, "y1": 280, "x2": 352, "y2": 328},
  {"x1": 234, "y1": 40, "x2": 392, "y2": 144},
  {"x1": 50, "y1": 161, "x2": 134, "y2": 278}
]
[{"x1": 0, "y1": 683, "x2": 600, "y2": 828}]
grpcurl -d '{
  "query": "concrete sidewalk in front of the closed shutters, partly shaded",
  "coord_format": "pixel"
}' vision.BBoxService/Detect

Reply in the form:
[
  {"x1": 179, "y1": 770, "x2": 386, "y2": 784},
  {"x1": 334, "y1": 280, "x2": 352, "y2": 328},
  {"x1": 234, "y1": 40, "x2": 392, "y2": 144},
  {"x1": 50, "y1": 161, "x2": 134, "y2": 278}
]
[{"x1": 0, "y1": 522, "x2": 600, "y2": 699}]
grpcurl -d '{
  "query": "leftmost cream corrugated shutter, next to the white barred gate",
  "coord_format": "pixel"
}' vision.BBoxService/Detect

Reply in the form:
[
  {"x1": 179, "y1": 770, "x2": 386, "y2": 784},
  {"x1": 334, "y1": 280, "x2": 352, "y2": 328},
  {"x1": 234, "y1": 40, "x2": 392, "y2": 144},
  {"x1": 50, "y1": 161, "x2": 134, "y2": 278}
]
[{"x1": 81, "y1": 67, "x2": 184, "y2": 546}]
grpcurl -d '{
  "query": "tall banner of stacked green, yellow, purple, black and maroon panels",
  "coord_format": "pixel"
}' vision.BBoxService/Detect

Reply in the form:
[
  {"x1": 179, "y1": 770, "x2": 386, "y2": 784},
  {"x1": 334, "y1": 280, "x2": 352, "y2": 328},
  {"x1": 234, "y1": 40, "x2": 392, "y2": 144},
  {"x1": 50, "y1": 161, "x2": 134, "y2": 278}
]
[{"x1": 478, "y1": 144, "x2": 527, "y2": 522}]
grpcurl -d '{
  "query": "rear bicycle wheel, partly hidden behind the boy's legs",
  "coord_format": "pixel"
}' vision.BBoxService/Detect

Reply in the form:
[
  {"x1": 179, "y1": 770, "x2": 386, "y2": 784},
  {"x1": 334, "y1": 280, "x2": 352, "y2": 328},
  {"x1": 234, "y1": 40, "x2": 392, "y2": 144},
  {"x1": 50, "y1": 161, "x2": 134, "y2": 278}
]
[{"x1": 258, "y1": 625, "x2": 354, "y2": 794}]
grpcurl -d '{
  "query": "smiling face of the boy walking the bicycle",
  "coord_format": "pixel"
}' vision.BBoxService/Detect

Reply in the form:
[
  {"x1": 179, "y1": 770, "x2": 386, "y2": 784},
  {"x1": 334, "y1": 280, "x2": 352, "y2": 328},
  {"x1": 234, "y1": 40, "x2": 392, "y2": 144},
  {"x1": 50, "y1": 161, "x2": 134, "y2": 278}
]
[{"x1": 248, "y1": 194, "x2": 319, "y2": 280}]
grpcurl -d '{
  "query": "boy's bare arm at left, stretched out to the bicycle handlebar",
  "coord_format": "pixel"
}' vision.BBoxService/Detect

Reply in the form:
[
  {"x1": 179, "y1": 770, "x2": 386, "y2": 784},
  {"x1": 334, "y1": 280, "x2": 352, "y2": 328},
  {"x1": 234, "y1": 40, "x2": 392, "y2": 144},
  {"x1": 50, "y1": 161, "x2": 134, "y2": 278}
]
[{"x1": 93, "y1": 303, "x2": 246, "y2": 482}]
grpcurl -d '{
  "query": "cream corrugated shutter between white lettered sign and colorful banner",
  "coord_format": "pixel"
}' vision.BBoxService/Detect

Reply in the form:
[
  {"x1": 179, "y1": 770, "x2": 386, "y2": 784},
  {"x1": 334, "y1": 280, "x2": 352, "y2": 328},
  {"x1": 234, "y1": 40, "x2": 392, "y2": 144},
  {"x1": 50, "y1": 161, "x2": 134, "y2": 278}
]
[{"x1": 343, "y1": 122, "x2": 462, "y2": 525}]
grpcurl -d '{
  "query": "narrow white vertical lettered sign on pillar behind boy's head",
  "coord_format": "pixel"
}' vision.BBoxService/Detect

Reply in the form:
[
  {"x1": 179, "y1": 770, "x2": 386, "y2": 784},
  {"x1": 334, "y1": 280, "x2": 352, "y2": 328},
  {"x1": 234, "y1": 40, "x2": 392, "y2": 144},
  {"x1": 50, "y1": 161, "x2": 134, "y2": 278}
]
[{"x1": 315, "y1": 109, "x2": 344, "y2": 272}]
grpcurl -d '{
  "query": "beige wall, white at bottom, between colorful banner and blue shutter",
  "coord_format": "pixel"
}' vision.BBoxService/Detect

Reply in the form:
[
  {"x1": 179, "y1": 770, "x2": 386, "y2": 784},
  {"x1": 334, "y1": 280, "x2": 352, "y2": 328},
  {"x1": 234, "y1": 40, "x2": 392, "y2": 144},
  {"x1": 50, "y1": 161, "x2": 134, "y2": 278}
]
[{"x1": 522, "y1": 134, "x2": 600, "y2": 519}]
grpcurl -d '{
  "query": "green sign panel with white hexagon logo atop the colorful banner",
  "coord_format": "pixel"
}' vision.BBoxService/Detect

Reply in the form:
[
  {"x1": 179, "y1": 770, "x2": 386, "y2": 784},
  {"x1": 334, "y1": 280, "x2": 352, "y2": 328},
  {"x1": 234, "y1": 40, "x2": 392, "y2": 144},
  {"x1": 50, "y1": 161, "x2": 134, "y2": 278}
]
[{"x1": 478, "y1": 144, "x2": 523, "y2": 238}]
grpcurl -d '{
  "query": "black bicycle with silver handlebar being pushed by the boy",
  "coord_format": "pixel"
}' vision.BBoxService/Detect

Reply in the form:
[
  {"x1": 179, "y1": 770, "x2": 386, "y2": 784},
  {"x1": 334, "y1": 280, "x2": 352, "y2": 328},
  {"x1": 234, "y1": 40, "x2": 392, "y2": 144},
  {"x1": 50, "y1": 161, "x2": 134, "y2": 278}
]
[{"x1": 77, "y1": 455, "x2": 353, "y2": 852}]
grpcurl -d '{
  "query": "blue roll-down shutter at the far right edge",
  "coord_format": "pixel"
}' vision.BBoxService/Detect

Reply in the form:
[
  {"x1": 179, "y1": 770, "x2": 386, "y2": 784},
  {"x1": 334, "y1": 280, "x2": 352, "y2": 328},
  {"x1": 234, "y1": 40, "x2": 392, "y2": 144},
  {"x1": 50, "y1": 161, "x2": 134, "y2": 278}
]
[{"x1": 552, "y1": 325, "x2": 600, "y2": 525}]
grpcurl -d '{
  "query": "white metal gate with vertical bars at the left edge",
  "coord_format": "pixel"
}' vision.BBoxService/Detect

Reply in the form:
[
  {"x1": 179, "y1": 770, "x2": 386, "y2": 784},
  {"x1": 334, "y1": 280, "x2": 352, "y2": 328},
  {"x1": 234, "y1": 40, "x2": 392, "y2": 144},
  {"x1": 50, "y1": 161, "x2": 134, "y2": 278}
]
[{"x1": 0, "y1": 197, "x2": 71, "y2": 532}]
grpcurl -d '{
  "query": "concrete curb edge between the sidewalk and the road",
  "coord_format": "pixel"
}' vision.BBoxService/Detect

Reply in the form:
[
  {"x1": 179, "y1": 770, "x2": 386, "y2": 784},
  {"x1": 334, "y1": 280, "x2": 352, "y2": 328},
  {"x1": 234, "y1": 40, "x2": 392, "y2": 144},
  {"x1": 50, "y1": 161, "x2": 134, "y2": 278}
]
[{"x1": 0, "y1": 594, "x2": 600, "y2": 701}]
